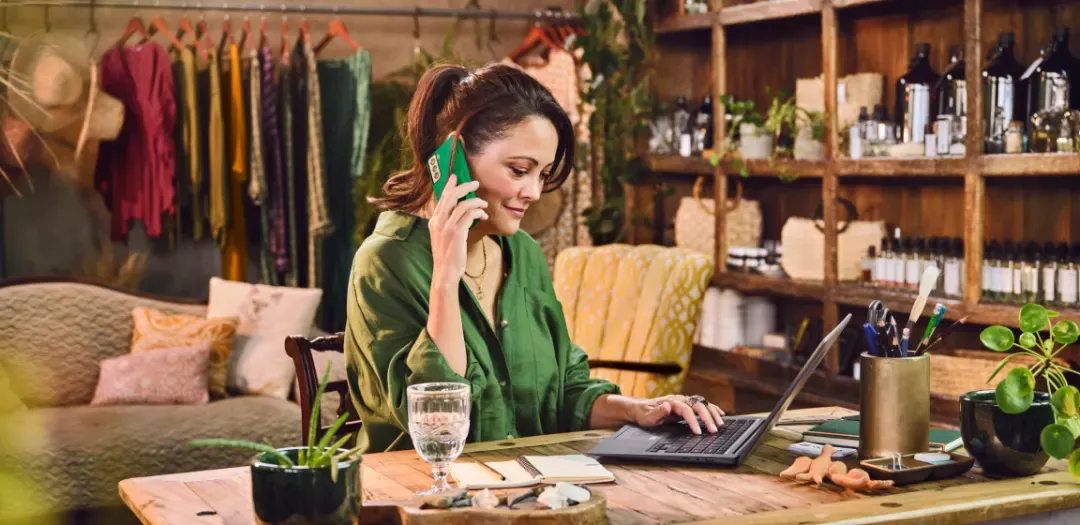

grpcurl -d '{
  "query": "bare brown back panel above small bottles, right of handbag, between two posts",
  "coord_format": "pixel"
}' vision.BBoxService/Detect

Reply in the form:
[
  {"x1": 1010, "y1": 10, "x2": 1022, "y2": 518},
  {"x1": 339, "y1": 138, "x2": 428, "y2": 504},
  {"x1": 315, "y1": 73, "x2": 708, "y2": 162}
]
[{"x1": 838, "y1": 178, "x2": 963, "y2": 238}]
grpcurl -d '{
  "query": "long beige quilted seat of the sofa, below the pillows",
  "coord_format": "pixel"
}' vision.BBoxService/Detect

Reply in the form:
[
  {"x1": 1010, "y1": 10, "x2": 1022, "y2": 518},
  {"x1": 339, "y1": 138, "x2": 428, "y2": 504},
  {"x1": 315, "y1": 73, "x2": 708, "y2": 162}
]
[{"x1": 0, "y1": 395, "x2": 300, "y2": 517}]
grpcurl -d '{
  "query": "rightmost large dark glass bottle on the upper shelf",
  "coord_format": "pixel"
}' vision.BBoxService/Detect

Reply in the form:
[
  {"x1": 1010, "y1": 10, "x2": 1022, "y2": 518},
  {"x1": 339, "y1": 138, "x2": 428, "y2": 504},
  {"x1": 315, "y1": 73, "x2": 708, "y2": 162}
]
[{"x1": 1022, "y1": 27, "x2": 1072, "y2": 123}]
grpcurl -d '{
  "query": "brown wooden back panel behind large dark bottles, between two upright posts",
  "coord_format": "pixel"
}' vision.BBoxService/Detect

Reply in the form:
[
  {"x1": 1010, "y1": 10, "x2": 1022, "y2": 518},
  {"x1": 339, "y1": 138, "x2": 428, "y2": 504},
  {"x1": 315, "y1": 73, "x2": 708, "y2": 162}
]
[{"x1": 838, "y1": 0, "x2": 963, "y2": 122}]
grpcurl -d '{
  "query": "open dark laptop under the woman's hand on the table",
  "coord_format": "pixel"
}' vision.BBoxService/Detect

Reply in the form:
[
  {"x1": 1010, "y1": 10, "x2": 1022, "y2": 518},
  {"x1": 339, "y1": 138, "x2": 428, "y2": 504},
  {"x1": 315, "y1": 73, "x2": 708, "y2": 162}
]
[{"x1": 588, "y1": 313, "x2": 851, "y2": 466}]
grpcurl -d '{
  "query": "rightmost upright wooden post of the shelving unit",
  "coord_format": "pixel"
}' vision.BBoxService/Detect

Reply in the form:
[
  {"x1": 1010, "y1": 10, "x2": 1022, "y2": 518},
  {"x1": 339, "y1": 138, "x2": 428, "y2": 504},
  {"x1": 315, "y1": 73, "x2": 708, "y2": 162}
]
[{"x1": 963, "y1": 0, "x2": 986, "y2": 306}]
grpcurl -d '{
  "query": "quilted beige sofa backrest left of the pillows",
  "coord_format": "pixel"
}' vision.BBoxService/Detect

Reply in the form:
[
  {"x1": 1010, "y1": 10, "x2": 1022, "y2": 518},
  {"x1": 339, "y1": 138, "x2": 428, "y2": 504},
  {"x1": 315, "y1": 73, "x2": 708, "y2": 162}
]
[{"x1": 0, "y1": 282, "x2": 206, "y2": 407}]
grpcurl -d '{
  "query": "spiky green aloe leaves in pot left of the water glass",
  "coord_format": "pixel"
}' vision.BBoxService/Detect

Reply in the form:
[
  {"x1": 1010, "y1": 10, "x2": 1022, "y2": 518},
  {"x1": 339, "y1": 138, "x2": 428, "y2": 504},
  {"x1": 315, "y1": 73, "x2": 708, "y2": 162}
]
[{"x1": 188, "y1": 363, "x2": 360, "y2": 481}]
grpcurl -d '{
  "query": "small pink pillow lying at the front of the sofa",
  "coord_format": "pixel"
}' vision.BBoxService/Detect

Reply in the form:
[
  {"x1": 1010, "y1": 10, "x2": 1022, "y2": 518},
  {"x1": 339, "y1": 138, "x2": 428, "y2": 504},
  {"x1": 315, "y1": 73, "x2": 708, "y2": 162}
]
[{"x1": 90, "y1": 344, "x2": 211, "y2": 406}]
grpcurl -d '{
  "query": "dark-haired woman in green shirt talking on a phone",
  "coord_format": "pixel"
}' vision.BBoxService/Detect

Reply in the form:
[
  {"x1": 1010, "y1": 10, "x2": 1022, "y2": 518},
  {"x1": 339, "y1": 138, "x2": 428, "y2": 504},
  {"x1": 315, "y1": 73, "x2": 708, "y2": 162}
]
[{"x1": 345, "y1": 65, "x2": 723, "y2": 453}]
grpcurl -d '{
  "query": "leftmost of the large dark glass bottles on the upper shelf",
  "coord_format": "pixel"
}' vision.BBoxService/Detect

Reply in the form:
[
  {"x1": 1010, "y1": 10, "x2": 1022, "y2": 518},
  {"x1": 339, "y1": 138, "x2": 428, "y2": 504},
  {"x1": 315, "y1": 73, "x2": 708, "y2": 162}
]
[{"x1": 896, "y1": 42, "x2": 941, "y2": 144}]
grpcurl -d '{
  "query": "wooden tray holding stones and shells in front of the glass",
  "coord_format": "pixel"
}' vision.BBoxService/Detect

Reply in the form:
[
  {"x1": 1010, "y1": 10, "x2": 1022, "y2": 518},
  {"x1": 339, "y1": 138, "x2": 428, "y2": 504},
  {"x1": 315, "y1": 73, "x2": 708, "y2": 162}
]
[{"x1": 359, "y1": 490, "x2": 608, "y2": 525}]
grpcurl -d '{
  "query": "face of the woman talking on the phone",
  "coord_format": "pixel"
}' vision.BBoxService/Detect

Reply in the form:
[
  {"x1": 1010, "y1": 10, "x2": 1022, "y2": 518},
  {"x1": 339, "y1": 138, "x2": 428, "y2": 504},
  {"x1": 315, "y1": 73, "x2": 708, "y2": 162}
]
[{"x1": 465, "y1": 117, "x2": 558, "y2": 235}]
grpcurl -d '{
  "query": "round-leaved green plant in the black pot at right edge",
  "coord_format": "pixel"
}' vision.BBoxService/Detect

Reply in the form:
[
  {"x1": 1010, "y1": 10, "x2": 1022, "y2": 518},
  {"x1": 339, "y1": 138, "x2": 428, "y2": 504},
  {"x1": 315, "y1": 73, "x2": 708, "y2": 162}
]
[{"x1": 978, "y1": 305, "x2": 1080, "y2": 481}]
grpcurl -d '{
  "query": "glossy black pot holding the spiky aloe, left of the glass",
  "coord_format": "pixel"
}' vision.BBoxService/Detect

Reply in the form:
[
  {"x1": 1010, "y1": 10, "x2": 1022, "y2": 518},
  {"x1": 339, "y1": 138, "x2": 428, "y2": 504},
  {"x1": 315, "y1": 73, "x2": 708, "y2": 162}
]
[{"x1": 252, "y1": 447, "x2": 362, "y2": 525}]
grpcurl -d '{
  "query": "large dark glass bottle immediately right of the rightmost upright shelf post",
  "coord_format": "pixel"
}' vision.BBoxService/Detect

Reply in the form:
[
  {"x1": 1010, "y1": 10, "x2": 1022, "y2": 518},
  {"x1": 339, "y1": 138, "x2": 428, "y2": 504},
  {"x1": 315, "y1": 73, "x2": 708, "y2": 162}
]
[{"x1": 983, "y1": 32, "x2": 1026, "y2": 146}]
